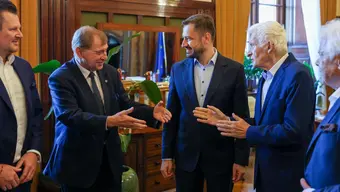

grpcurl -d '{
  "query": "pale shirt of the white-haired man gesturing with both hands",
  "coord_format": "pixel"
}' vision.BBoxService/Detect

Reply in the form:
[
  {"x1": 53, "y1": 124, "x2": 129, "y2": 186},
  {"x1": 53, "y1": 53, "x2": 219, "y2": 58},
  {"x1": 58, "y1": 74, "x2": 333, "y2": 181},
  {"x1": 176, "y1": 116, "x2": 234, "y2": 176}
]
[{"x1": 261, "y1": 53, "x2": 288, "y2": 109}]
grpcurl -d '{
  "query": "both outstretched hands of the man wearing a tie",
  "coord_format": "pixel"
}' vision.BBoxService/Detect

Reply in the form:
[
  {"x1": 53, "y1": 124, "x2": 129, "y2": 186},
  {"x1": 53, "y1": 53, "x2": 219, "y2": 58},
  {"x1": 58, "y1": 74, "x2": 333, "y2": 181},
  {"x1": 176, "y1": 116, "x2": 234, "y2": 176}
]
[{"x1": 107, "y1": 101, "x2": 172, "y2": 129}]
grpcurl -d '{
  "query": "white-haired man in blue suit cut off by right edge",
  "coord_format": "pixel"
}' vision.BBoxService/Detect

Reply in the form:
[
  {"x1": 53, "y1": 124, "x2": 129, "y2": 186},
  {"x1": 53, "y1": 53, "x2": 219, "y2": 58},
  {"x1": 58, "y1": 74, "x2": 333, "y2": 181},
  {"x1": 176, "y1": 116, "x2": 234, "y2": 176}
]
[{"x1": 301, "y1": 20, "x2": 340, "y2": 192}]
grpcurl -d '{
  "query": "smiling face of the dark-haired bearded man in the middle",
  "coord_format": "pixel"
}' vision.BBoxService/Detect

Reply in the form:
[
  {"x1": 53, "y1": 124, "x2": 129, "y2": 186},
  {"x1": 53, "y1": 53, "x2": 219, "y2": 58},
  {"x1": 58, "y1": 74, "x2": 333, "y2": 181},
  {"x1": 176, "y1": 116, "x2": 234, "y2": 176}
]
[{"x1": 182, "y1": 24, "x2": 206, "y2": 59}]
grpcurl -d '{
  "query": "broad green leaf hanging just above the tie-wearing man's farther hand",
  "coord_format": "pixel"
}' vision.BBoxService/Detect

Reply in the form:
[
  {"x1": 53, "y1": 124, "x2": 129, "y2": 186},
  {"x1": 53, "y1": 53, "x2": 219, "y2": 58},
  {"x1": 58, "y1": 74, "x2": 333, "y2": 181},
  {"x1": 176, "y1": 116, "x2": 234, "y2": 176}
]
[{"x1": 140, "y1": 80, "x2": 162, "y2": 104}]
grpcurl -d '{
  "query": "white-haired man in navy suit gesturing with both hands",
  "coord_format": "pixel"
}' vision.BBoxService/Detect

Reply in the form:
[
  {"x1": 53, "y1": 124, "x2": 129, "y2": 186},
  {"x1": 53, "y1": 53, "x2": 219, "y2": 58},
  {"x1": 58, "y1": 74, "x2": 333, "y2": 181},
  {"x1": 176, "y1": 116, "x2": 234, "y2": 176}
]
[{"x1": 196, "y1": 21, "x2": 315, "y2": 192}]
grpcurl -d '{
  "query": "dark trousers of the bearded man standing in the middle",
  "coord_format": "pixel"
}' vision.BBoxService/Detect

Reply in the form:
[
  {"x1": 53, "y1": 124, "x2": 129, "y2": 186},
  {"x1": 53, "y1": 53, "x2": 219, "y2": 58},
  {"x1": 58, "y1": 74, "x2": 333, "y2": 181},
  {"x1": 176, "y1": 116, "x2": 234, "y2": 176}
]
[{"x1": 176, "y1": 159, "x2": 233, "y2": 192}]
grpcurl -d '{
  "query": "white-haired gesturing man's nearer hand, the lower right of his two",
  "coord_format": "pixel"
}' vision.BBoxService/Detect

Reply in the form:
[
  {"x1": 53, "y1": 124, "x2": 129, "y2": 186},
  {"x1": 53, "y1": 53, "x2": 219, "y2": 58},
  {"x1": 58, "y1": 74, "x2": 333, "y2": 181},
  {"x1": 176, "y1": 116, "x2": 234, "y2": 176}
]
[{"x1": 216, "y1": 113, "x2": 250, "y2": 139}]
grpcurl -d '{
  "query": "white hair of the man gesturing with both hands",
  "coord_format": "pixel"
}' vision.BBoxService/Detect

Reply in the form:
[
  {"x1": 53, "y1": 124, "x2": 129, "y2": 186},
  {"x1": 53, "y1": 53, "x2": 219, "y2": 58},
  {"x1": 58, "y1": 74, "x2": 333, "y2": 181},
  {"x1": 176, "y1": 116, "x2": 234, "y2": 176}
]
[{"x1": 248, "y1": 21, "x2": 288, "y2": 55}]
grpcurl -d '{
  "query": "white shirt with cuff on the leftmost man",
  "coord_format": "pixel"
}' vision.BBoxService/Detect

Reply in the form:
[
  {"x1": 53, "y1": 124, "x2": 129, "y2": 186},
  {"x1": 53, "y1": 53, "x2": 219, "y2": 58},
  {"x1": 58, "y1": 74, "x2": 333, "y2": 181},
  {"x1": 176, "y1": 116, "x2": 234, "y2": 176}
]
[{"x1": 0, "y1": 55, "x2": 41, "y2": 163}]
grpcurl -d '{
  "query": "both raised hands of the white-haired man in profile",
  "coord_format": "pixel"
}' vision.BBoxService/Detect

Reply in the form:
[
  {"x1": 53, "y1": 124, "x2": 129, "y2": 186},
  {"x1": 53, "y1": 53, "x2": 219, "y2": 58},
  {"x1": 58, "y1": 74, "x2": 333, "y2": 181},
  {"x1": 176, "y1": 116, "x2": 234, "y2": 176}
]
[{"x1": 193, "y1": 105, "x2": 250, "y2": 139}]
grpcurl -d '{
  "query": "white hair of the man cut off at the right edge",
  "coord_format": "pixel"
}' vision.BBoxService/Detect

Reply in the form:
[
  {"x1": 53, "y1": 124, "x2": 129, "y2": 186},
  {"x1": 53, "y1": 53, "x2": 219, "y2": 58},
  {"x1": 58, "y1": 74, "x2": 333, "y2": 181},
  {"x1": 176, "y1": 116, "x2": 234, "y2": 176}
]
[{"x1": 319, "y1": 19, "x2": 340, "y2": 60}]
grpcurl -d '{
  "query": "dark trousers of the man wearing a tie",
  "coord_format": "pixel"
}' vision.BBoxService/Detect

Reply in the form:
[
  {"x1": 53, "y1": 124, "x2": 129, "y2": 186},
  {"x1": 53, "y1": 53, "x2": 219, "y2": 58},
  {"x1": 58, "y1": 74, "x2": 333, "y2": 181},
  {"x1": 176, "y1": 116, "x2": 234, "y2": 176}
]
[{"x1": 61, "y1": 148, "x2": 122, "y2": 192}]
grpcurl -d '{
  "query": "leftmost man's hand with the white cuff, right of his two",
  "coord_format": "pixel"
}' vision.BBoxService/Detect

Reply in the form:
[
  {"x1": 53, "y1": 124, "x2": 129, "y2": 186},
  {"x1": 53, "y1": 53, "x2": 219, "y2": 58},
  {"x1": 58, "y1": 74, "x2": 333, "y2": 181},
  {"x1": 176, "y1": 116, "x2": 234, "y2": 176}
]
[{"x1": 16, "y1": 152, "x2": 38, "y2": 184}]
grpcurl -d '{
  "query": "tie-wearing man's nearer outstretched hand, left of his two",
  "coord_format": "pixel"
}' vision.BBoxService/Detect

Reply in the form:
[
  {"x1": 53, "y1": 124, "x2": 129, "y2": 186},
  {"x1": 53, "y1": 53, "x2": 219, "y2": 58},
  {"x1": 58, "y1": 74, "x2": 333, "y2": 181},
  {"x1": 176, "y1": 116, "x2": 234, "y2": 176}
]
[{"x1": 107, "y1": 107, "x2": 146, "y2": 129}]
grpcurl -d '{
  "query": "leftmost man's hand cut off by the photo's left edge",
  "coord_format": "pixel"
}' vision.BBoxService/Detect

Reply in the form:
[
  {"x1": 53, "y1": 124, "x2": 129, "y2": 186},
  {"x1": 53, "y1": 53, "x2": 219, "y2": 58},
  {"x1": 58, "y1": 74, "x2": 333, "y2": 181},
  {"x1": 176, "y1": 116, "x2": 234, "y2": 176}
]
[{"x1": 0, "y1": 164, "x2": 21, "y2": 191}]
